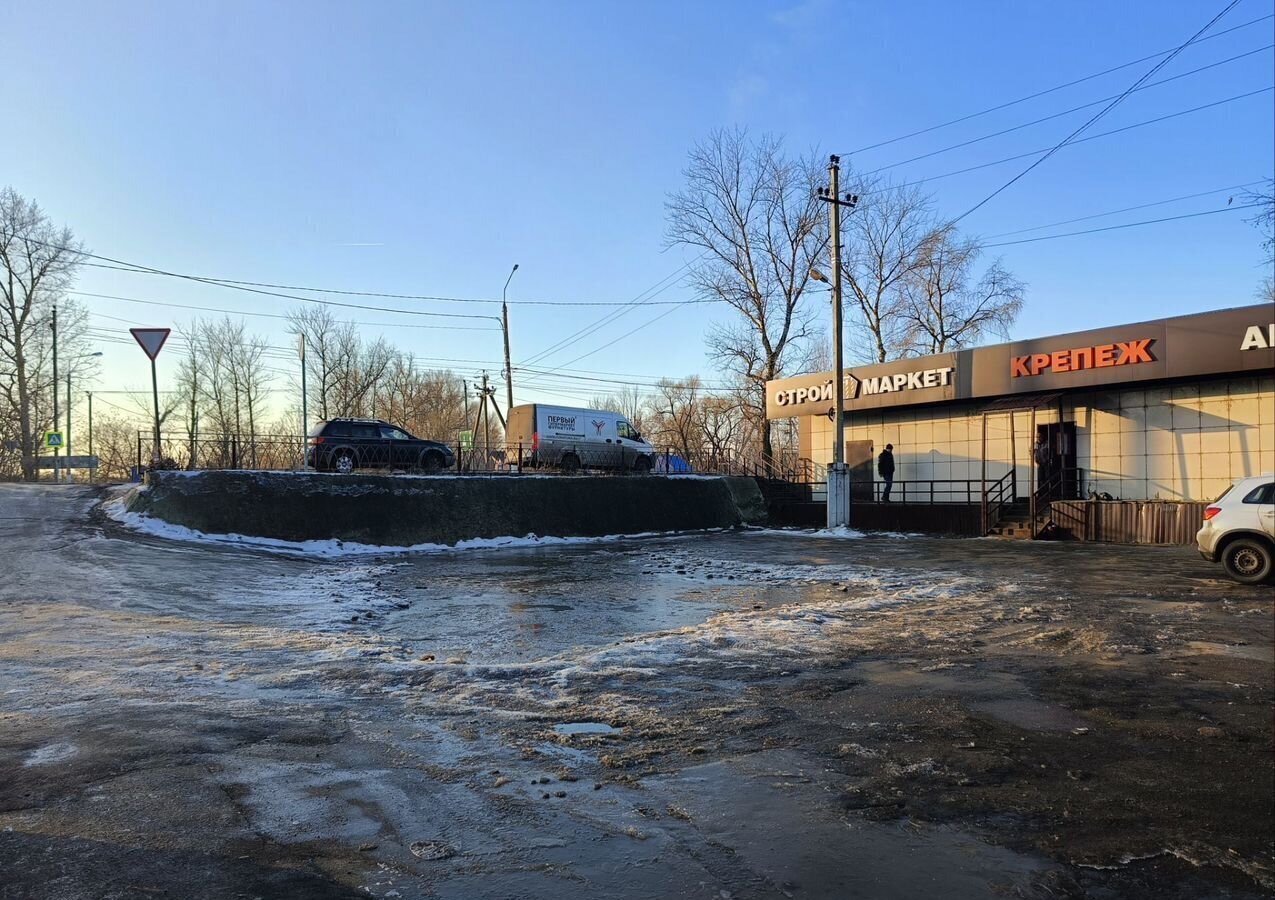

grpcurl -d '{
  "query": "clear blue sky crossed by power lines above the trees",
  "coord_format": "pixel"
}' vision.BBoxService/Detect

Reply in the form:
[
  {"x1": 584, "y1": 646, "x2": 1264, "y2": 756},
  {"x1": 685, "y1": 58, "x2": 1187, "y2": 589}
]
[{"x1": 0, "y1": 0, "x2": 1275, "y2": 410}]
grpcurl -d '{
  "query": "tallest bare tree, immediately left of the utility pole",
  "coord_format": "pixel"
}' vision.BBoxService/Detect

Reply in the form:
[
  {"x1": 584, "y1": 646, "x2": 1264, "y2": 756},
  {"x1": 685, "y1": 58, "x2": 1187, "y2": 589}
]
[{"x1": 666, "y1": 130, "x2": 827, "y2": 460}]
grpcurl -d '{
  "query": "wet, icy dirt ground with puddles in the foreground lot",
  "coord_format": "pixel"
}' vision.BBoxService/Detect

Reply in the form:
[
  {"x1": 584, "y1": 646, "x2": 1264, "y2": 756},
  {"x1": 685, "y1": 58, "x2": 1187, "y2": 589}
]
[{"x1": 0, "y1": 486, "x2": 1275, "y2": 900}]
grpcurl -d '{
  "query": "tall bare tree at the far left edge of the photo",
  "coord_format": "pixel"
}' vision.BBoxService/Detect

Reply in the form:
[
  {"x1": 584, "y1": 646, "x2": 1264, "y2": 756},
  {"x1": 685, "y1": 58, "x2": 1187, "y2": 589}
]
[{"x1": 0, "y1": 187, "x2": 82, "y2": 481}]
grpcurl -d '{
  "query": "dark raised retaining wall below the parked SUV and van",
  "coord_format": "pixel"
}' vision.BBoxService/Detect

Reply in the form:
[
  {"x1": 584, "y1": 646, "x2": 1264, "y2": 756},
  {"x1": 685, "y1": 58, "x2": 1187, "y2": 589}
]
[{"x1": 129, "y1": 472, "x2": 766, "y2": 546}]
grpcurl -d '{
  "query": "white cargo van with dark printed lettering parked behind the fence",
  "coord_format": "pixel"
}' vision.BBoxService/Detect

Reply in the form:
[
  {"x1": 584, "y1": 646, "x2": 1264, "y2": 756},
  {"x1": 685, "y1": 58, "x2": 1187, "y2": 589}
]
[{"x1": 506, "y1": 403, "x2": 655, "y2": 474}]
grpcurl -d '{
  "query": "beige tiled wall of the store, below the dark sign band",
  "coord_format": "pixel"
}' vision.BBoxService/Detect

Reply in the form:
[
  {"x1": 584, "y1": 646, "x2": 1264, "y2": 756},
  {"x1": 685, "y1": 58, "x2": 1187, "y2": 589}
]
[{"x1": 799, "y1": 375, "x2": 1275, "y2": 501}]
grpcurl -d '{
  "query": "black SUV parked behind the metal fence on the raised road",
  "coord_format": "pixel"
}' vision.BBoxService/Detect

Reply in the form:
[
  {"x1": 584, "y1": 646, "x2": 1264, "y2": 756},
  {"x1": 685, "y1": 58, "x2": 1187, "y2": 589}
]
[{"x1": 306, "y1": 418, "x2": 456, "y2": 475}]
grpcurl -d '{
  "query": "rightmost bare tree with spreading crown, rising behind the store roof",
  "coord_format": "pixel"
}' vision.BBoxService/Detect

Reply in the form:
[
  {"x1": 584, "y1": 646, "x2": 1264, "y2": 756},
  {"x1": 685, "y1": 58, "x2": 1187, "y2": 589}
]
[{"x1": 899, "y1": 224, "x2": 1026, "y2": 354}]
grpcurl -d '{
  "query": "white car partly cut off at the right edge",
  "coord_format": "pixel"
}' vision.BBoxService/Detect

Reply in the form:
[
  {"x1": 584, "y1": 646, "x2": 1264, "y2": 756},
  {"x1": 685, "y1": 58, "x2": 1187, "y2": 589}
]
[{"x1": 1196, "y1": 473, "x2": 1275, "y2": 584}]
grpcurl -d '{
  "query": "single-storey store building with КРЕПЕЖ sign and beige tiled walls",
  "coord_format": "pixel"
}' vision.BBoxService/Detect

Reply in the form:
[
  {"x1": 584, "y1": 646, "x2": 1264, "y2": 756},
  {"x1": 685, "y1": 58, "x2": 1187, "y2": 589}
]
[{"x1": 766, "y1": 303, "x2": 1275, "y2": 504}]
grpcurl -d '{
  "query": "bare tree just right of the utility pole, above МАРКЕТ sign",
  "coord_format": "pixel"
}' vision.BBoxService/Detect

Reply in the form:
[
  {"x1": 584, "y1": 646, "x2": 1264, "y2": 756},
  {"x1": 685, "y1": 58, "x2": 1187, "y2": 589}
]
[{"x1": 842, "y1": 185, "x2": 935, "y2": 362}]
